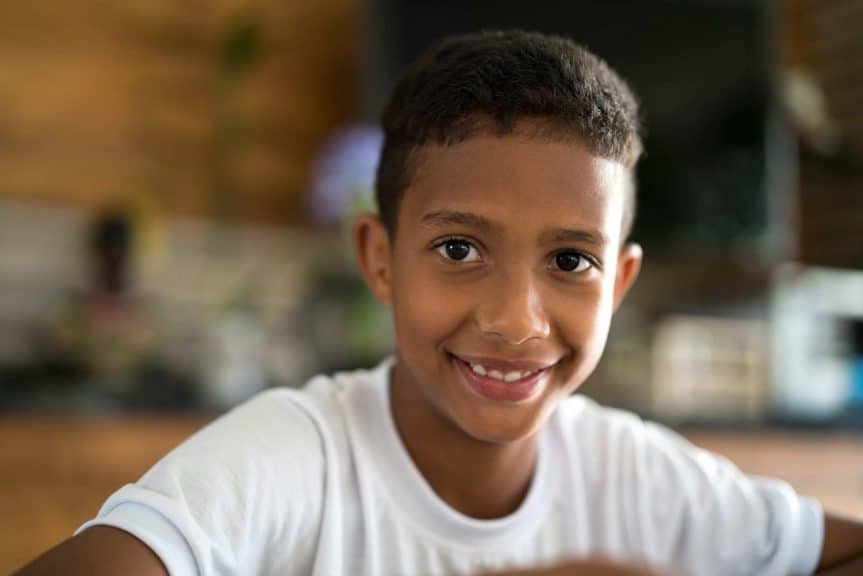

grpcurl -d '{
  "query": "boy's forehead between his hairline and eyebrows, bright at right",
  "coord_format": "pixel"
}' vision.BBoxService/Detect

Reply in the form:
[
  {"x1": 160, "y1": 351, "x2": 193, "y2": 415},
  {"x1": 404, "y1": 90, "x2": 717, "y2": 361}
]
[{"x1": 399, "y1": 135, "x2": 626, "y2": 238}]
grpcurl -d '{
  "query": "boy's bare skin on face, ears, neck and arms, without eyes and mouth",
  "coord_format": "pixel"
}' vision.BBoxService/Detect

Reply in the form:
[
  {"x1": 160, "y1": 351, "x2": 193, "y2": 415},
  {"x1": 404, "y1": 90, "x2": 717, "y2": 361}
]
[{"x1": 13, "y1": 134, "x2": 863, "y2": 576}]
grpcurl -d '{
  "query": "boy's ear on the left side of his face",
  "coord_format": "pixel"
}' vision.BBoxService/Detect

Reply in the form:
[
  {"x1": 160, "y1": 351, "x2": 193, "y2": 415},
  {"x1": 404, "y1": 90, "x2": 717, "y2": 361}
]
[{"x1": 353, "y1": 212, "x2": 392, "y2": 306}]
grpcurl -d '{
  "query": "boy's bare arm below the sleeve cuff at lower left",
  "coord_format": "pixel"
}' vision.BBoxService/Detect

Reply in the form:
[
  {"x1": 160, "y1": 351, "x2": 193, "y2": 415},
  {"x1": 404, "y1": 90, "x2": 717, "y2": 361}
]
[{"x1": 13, "y1": 526, "x2": 168, "y2": 576}]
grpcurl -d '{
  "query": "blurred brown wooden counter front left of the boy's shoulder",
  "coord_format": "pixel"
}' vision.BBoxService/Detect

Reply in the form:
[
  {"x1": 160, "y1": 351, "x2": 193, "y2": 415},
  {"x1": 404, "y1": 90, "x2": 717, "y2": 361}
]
[{"x1": 0, "y1": 415, "x2": 211, "y2": 574}]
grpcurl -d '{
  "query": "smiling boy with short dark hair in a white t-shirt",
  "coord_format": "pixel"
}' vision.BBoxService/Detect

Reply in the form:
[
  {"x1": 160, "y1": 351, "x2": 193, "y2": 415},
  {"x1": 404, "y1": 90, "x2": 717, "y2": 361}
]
[{"x1": 15, "y1": 32, "x2": 863, "y2": 575}]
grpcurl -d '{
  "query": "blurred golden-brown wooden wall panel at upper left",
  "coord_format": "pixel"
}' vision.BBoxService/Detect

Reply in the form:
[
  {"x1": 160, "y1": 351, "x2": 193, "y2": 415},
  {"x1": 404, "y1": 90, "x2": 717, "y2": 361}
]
[{"x1": 0, "y1": 0, "x2": 359, "y2": 222}]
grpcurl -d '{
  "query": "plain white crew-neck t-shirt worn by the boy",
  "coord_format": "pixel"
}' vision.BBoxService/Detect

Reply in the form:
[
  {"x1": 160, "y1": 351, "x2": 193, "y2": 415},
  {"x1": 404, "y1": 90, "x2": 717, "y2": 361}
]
[{"x1": 79, "y1": 360, "x2": 824, "y2": 576}]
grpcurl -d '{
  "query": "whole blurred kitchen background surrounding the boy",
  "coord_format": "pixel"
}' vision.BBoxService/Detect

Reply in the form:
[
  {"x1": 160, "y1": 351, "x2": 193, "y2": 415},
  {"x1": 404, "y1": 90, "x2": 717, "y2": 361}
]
[{"x1": 0, "y1": 0, "x2": 863, "y2": 572}]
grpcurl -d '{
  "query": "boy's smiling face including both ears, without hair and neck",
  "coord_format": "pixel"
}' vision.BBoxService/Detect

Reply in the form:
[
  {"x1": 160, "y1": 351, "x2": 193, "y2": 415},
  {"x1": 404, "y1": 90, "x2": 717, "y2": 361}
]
[{"x1": 355, "y1": 134, "x2": 641, "y2": 442}]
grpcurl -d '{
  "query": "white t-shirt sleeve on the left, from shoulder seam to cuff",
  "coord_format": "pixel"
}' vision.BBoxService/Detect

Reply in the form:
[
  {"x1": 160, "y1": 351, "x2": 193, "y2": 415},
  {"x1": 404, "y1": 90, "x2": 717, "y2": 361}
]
[{"x1": 76, "y1": 390, "x2": 324, "y2": 575}]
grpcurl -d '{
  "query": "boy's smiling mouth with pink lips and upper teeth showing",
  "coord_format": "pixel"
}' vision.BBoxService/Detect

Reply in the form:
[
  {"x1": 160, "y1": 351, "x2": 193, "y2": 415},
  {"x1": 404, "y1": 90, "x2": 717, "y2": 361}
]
[{"x1": 450, "y1": 354, "x2": 554, "y2": 403}]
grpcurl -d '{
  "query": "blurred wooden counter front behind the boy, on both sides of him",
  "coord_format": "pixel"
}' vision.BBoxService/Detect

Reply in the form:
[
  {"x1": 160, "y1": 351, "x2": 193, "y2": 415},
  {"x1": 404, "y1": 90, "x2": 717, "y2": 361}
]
[{"x1": 0, "y1": 415, "x2": 863, "y2": 574}]
